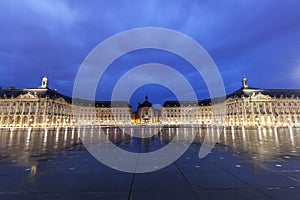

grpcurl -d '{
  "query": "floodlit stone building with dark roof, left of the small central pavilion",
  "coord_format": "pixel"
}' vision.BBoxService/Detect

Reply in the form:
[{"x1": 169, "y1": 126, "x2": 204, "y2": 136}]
[{"x1": 0, "y1": 77, "x2": 132, "y2": 127}]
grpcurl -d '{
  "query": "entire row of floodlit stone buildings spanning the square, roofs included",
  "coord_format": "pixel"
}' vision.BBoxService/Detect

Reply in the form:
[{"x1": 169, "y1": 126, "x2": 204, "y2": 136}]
[{"x1": 0, "y1": 77, "x2": 300, "y2": 127}]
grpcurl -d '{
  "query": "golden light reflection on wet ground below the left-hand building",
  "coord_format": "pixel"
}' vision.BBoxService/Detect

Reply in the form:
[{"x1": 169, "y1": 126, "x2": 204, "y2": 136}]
[{"x1": 0, "y1": 127, "x2": 80, "y2": 175}]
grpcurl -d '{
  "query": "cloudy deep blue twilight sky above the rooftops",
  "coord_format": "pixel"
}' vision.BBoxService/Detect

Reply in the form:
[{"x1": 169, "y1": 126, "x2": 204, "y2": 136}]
[{"x1": 0, "y1": 0, "x2": 300, "y2": 107}]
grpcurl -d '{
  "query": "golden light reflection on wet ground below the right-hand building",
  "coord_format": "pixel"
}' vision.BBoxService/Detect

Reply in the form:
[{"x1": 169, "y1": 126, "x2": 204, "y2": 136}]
[{"x1": 214, "y1": 127, "x2": 300, "y2": 161}]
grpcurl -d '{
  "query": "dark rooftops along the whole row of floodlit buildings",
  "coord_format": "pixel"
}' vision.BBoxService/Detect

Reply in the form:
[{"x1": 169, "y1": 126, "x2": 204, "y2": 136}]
[{"x1": 0, "y1": 76, "x2": 300, "y2": 108}]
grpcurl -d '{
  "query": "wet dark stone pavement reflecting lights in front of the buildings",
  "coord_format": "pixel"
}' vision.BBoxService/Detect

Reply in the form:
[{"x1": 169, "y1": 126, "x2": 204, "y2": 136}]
[{"x1": 0, "y1": 129, "x2": 300, "y2": 200}]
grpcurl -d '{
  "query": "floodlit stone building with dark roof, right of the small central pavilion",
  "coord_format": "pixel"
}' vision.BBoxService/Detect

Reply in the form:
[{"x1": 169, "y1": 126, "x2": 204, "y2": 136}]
[{"x1": 161, "y1": 78, "x2": 300, "y2": 127}]
